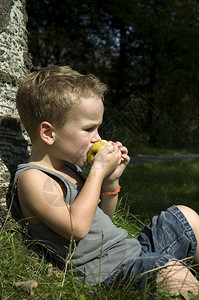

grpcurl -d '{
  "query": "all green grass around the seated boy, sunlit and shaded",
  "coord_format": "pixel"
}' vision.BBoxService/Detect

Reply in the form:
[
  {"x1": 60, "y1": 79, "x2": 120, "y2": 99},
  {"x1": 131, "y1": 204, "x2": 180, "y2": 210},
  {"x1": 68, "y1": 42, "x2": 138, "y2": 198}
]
[{"x1": 0, "y1": 159, "x2": 199, "y2": 300}]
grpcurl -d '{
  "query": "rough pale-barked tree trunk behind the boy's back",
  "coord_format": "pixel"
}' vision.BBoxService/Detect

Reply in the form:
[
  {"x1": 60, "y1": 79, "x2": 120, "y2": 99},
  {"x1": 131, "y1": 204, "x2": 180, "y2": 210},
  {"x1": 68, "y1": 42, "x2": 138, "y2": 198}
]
[{"x1": 0, "y1": 0, "x2": 31, "y2": 225}]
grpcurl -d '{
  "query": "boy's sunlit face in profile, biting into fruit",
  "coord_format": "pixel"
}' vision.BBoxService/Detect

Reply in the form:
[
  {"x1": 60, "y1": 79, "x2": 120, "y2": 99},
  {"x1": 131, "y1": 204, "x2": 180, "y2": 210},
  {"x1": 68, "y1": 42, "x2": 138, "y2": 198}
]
[{"x1": 54, "y1": 96, "x2": 104, "y2": 167}]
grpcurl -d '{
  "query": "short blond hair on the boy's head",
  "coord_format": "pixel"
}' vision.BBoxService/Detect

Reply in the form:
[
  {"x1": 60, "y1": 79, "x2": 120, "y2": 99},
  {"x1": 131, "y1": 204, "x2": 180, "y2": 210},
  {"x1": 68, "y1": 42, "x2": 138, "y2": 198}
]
[{"x1": 16, "y1": 66, "x2": 107, "y2": 139}]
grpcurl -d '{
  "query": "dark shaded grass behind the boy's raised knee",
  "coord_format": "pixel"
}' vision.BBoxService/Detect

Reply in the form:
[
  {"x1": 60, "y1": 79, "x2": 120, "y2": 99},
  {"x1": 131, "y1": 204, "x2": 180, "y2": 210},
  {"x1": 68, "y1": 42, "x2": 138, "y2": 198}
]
[{"x1": 120, "y1": 159, "x2": 199, "y2": 220}]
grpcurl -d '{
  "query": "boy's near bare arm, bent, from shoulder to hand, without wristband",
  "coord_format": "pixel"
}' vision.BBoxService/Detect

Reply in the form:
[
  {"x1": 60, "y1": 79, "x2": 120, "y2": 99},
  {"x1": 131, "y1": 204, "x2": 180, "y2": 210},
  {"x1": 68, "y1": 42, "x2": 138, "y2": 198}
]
[{"x1": 18, "y1": 145, "x2": 121, "y2": 240}]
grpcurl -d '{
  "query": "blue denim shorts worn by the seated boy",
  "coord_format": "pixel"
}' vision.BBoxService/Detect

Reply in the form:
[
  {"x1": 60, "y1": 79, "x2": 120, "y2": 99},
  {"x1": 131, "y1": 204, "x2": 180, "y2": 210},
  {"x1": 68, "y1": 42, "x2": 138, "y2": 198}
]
[{"x1": 104, "y1": 205, "x2": 197, "y2": 290}]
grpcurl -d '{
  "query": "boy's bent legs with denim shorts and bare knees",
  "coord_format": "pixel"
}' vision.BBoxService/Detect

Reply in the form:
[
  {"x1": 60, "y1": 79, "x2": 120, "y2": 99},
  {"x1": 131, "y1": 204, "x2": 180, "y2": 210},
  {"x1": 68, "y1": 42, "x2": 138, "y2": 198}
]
[{"x1": 105, "y1": 206, "x2": 199, "y2": 299}]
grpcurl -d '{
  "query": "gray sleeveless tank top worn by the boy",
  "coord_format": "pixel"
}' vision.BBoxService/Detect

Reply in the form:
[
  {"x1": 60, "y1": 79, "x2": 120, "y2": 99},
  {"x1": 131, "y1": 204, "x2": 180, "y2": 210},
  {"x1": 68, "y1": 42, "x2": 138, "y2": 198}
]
[{"x1": 13, "y1": 163, "x2": 140, "y2": 285}]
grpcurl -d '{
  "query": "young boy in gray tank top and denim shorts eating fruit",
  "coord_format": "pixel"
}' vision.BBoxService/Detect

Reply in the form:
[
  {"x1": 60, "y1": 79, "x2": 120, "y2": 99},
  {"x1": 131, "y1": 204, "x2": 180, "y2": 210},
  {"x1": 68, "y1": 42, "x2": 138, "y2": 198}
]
[{"x1": 13, "y1": 66, "x2": 199, "y2": 299}]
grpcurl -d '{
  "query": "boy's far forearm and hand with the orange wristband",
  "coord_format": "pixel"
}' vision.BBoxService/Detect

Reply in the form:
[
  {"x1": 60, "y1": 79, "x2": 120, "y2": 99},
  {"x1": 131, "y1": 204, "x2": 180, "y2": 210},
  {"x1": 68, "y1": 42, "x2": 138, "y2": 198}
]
[{"x1": 99, "y1": 142, "x2": 130, "y2": 218}]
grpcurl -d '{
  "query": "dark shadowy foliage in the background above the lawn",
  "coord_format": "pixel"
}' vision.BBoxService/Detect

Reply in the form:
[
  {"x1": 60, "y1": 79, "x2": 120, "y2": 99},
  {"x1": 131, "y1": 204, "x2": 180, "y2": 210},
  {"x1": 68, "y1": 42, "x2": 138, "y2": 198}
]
[{"x1": 27, "y1": 0, "x2": 199, "y2": 148}]
